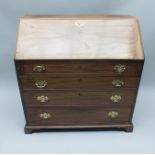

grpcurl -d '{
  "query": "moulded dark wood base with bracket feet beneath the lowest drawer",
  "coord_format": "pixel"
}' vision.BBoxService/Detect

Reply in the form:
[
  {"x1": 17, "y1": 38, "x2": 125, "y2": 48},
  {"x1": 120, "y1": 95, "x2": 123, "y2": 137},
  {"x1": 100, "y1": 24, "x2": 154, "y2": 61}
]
[{"x1": 25, "y1": 123, "x2": 133, "y2": 134}]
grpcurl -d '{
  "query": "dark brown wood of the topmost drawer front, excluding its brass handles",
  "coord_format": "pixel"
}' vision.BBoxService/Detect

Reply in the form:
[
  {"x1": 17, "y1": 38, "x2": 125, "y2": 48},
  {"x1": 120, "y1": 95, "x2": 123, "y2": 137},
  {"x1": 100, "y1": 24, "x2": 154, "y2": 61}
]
[{"x1": 16, "y1": 60, "x2": 143, "y2": 77}]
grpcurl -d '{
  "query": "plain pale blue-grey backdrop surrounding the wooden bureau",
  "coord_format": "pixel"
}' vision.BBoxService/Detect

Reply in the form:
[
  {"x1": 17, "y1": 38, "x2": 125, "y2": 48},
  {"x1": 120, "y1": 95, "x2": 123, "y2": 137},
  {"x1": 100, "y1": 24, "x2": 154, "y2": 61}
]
[{"x1": 0, "y1": 0, "x2": 155, "y2": 153}]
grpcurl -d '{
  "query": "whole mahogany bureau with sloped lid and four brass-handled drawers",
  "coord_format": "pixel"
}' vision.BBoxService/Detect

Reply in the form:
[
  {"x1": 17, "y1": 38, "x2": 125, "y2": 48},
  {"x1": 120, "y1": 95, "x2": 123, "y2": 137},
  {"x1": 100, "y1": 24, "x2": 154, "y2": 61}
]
[{"x1": 15, "y1": 16, "x2": 144, "y2": 133}]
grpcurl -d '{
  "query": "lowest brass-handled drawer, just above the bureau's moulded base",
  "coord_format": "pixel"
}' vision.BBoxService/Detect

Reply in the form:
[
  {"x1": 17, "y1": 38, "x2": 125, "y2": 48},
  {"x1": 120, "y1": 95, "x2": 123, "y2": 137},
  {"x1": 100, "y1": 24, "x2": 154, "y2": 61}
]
[{"x1": 26, "y1": 108, "x2": 131, "y2": 125}]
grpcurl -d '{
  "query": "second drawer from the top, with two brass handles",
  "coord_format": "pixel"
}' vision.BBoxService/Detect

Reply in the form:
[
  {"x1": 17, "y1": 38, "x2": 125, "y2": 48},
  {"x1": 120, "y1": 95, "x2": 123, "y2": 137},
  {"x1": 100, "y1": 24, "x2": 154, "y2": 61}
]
[{"x1": 21, "y1": 77, "x2": 139, "y2": 90}]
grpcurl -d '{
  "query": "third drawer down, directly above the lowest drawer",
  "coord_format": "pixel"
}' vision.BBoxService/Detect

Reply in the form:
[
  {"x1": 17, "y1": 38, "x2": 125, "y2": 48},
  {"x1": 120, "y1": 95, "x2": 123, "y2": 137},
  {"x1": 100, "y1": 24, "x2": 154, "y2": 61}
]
[{"x1": 23, "y1": 90, "x2": 136, "y2": 107}]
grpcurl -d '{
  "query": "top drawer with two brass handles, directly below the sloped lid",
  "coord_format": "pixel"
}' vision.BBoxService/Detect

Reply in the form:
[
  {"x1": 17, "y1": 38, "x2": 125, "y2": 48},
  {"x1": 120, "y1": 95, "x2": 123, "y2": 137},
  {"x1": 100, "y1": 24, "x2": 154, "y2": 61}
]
[{"x1": 16, "y1": 60, "x2": 142, "y2": 76}]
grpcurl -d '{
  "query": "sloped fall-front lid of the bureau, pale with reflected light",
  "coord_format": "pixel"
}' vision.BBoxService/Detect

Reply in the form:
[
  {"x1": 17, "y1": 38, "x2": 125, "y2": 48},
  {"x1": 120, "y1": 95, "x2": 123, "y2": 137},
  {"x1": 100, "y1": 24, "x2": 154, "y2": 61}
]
[{"x1": 15, "y1": 16, "x2": 144, "y2": 60}]
